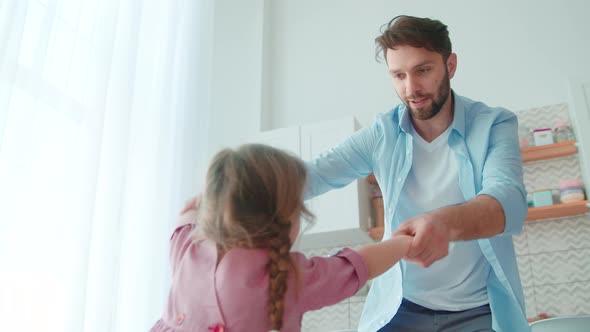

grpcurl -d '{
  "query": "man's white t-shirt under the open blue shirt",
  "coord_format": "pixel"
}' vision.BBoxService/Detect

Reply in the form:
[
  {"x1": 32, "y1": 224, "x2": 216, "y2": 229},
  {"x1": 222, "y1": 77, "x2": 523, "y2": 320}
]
[{"x1": 394, "y1": 126, "x2": 491, "y2": 311}]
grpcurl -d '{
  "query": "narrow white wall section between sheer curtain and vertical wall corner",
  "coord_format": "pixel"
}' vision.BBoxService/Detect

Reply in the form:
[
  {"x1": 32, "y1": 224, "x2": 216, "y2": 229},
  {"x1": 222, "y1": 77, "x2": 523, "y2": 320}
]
[{"x1": 209, "y1": 0, "x2": 264, "y2": 154}]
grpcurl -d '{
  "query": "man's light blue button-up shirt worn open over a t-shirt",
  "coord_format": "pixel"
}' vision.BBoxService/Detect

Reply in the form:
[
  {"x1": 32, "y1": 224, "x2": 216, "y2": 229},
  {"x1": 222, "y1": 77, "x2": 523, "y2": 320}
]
[{"x1": 306, "y1": 94, "x2": 530, "y2": 332}]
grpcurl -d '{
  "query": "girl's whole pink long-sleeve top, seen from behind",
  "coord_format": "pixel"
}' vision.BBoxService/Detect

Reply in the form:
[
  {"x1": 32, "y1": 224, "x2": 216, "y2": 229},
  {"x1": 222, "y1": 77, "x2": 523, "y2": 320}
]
[{"x1": 151, "y1": 224, "x2": 368, "y2": 332}]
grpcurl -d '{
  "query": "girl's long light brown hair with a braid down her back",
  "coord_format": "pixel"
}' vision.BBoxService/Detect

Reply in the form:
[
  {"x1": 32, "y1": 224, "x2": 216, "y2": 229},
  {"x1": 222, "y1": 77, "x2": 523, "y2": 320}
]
[{"x1": 197, "y1": 144, "x2": 312, "y2": 330}]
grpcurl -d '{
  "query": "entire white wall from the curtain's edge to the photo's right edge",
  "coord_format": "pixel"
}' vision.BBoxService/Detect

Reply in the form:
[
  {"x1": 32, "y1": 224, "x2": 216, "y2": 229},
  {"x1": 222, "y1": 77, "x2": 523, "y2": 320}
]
[{"x1": 210, "y1": 0, "x2": 590, "y2": 150}]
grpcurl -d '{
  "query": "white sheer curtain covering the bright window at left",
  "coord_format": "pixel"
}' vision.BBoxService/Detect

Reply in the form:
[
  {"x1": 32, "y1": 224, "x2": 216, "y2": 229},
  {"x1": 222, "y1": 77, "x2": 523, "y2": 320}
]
[{"x1": 0, "y1": 0, "x2": 211, "y2": 332}]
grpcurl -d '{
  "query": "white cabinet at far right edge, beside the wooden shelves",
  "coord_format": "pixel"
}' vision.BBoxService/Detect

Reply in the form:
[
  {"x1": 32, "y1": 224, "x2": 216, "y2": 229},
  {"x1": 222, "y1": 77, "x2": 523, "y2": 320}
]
[{"x1": 569, "y1": 80, "x2": 590, "y2": 185}]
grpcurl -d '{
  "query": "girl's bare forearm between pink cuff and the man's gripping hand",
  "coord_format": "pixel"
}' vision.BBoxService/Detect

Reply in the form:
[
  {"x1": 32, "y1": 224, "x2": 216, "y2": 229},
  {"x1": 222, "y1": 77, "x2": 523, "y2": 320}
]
[{"x1": 356, "y1": 235, "x2": 412, "y2": 279}]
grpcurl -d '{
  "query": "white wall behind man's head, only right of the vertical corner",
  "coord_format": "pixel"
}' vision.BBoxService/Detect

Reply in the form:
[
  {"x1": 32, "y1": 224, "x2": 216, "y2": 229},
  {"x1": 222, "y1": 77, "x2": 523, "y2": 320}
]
[{"x1": 264, "y1": 0, "x2": 590, "y2": 127}]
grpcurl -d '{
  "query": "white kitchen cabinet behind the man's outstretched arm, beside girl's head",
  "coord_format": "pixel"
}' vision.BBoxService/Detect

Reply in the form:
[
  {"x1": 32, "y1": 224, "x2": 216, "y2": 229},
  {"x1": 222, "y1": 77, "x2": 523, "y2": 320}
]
[{"x1": 254, "y1": 117, "x2": 372, "y2": 249}]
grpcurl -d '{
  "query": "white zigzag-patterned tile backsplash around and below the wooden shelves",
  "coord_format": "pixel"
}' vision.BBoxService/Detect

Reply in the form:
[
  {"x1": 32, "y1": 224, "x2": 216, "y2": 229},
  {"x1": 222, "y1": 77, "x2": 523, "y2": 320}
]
[{"x1": 302, "y1": 104, "x2": 590, "y2": 332}]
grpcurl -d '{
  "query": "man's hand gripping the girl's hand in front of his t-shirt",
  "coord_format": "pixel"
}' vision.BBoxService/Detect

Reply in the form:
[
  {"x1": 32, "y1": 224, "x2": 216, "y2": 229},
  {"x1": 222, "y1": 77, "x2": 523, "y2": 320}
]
[{"x1": 392, "y1": 214, "x2": 450, "y2": 267}]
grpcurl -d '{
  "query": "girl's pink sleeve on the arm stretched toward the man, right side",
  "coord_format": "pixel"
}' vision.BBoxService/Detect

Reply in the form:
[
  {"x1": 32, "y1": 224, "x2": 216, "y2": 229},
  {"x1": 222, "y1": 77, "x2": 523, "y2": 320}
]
[{"x1": 294, "y1": 248, "x2": 369, "y2": 312}]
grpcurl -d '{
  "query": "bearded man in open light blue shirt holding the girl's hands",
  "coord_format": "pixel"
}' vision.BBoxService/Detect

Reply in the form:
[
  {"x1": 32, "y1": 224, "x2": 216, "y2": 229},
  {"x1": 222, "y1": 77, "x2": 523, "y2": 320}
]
[{"x1": 307, "y1": 16, "x2": 529, "y2": 332}]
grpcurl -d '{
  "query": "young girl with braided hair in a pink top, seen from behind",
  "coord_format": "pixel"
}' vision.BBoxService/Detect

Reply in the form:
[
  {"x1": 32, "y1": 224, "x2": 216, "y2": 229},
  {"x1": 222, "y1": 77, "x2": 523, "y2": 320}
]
[{"x1": 151, "y1": 144, "x2": 411, "y2": 332}]
